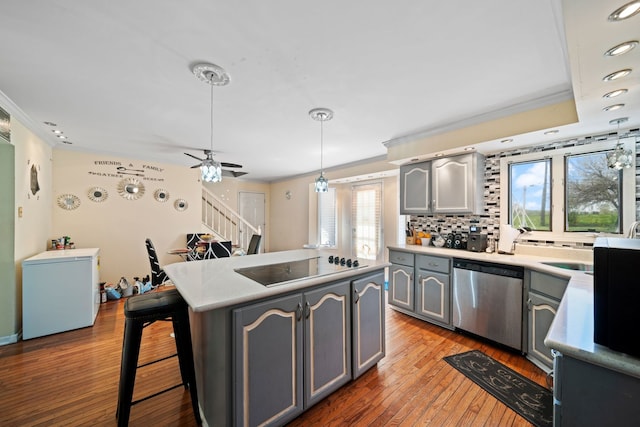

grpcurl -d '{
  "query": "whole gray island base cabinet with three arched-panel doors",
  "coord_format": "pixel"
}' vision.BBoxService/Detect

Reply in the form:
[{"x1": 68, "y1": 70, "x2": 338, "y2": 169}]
[{"x1": 230, "y1": 271, "x2": 385, "y2": 426}]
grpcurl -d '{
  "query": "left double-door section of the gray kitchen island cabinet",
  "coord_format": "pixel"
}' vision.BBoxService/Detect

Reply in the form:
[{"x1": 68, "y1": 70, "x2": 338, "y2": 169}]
[{"x1": 233, "y1": 282, "x2": 351, "y2": 426}]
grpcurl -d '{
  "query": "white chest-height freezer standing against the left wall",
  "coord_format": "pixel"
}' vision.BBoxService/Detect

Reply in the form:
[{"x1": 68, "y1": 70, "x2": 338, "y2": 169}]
[{"x1": 22, "y1": 248, "x2": 100, "y2": 339}]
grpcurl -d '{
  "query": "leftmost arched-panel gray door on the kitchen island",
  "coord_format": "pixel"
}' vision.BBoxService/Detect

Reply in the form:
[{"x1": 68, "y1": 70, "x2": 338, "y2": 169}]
[{"x1": 233, "y1": 294, "x2": 303, "y2": 426}]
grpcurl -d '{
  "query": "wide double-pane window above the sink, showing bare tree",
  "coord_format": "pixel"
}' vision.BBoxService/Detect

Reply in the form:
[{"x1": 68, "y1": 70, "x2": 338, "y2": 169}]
[{"x1": 500, "y1": 138, "x2": 635, "y2": 242}]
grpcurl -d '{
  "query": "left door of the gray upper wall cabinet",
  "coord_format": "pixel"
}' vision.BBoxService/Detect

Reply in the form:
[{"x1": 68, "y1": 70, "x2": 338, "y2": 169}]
[{"x1": 400, "y1": 162, "x2": 431, "y2": 215}]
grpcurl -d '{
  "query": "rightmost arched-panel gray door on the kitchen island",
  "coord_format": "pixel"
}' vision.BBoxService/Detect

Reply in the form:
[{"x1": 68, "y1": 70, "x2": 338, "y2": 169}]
[{"x1": 353, "y1": 273, "x2": 385, "y2": 378}]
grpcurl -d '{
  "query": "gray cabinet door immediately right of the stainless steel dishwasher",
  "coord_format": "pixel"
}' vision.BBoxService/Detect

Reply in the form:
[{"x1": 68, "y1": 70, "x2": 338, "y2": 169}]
[{"x1": 527, "y1": 292, "x2": 559, "y2": 368}]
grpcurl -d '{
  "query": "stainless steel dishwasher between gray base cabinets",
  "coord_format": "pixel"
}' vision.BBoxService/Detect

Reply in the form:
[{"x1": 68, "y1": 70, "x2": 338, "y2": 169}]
[{"x1": 452, "y1": 258, "x2": 524, "y2": 351}]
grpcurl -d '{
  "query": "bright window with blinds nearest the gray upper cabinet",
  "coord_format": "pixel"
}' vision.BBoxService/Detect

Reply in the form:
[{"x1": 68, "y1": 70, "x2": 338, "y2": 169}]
[{"x1": 351, "y1": 183, "x2": 382, "y2": 259}]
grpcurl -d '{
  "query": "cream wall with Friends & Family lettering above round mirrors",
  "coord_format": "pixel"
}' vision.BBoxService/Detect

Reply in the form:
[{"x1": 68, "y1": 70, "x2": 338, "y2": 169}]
[{"x1": 48, "y1": 149, "x2": 202, "y2": 283}]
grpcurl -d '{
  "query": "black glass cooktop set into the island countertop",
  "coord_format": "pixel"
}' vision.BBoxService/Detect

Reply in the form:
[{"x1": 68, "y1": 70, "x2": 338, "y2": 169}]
[{"x1": 234, "y1": 257, "x2": 364, "y2": 287}]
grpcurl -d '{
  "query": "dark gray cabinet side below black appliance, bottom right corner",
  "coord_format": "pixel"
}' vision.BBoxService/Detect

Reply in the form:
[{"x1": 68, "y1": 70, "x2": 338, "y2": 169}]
[{"x1": 553, "y1": 353, "x2": 640, "y2": 427}]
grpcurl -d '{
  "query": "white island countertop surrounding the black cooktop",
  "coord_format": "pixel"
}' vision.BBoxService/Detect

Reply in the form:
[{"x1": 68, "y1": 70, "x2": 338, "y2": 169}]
[{"x1": 163, "y1": 249, "x2": 390, "y2": 311}]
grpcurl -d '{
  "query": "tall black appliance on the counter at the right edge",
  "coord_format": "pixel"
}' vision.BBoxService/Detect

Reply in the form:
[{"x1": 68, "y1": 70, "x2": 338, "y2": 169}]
[{"x1": 593, "y1": 237, "x2": 640, "y2": 357}]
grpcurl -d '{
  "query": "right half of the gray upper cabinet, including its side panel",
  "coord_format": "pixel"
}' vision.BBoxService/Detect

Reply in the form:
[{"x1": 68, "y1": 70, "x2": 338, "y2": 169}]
[{"x1": 431, "y1": 153, "x2": 484, "y2": 214}]
